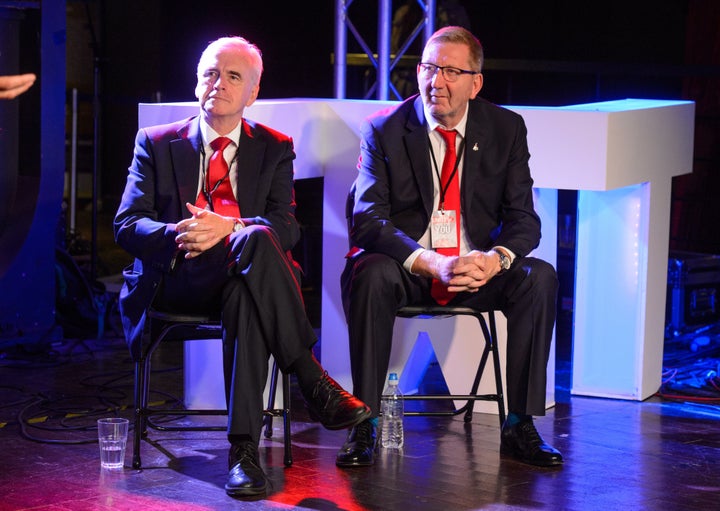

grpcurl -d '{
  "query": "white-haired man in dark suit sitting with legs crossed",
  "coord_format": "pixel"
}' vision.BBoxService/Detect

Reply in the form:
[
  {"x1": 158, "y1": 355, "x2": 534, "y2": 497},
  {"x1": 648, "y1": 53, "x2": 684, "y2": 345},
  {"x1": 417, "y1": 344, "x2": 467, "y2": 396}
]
[{"x1": 114, "y1": 37, "x2": 370, "y2": 496}]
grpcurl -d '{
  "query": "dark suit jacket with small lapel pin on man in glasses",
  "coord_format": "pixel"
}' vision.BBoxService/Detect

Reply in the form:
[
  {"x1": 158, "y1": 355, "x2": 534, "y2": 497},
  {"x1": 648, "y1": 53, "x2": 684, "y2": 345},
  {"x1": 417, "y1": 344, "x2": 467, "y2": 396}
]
[{"x1": 350, "y1": 95, "x2": 540, "y2": 263}]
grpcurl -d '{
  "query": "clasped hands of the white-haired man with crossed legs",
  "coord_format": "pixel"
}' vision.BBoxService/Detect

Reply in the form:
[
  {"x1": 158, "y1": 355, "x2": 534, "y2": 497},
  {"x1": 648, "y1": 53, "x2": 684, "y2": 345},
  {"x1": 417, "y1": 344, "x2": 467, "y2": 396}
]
[{"x1": 175, "y1": 203, "x2": 234, "y2": 259}]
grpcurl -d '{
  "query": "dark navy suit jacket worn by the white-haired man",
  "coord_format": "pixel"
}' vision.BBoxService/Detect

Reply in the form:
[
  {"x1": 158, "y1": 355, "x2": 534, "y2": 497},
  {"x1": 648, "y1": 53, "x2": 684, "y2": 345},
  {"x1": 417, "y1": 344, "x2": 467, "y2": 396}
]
[{"x1": 114, "y1": 117, "x2": 300, "y2": 357}]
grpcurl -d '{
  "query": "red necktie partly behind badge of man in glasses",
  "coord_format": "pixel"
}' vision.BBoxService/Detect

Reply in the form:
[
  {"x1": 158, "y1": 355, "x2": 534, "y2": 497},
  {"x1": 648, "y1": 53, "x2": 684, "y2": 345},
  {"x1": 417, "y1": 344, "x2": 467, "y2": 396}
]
[{"x1": 430, "y1": 127, "x2": 460, "y2": 305}]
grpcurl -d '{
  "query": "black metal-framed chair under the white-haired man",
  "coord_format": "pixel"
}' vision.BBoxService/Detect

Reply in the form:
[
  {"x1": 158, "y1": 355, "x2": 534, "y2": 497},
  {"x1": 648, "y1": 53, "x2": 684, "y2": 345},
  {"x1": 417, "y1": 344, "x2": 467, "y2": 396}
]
[{"x1": 132, "y1": 309, "x2": 292, "y2": 469}]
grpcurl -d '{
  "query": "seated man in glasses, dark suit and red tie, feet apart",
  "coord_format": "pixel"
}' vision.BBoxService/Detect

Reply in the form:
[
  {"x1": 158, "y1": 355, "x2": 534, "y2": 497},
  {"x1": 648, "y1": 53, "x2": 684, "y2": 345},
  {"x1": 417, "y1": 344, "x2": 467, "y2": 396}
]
[{"x1": 336, "y1": 26, "x2": 563, "y2": 467}]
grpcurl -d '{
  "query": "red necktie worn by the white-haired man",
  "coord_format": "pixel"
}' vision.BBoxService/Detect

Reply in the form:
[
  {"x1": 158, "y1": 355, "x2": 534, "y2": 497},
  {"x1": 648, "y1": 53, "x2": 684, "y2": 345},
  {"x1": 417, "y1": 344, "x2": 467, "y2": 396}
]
[{"x1": 195, "y1": 137, "x2": 240, "y2": 217}]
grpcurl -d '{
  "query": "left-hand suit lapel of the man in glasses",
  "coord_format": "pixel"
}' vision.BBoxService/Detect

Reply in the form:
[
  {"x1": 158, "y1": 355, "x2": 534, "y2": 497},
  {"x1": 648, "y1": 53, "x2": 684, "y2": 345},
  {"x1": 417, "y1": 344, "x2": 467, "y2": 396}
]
[{"x1": 405, "y1": 96, "x2": 433, "y2": 216}]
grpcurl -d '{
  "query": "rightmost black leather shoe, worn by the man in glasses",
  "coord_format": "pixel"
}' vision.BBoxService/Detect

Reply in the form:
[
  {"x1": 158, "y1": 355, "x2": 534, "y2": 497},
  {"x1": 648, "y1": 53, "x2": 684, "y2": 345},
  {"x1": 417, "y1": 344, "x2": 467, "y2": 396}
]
[{"x1": 500, "y1": 419, "x2": 563, "y2": 467}]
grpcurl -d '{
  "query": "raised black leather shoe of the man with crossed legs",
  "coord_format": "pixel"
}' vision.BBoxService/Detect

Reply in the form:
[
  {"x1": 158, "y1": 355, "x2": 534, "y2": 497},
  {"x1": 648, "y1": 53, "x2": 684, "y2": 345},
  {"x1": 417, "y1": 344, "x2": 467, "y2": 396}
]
[{"x1": 301, "y1": 371, "x2": 370, "y2": 429}]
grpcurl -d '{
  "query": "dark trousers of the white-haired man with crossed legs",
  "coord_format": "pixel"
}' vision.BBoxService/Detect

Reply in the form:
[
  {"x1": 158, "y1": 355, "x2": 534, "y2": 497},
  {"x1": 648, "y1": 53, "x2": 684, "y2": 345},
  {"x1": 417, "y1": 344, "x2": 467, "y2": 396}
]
[{"x1": 156, "y1": 226, "x2": 317, "y2": 442}]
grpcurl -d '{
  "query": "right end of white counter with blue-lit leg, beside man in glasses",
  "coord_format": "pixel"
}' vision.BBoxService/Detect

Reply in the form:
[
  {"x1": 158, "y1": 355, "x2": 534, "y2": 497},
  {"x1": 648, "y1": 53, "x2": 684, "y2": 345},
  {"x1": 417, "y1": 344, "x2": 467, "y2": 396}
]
[{"x1": 512, "y1": 99, "x2": 695, "y2": 400}]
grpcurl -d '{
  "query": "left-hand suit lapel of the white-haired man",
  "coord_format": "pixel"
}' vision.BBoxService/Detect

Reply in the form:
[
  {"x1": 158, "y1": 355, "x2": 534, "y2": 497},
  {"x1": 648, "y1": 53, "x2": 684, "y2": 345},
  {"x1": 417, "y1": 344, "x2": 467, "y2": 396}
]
[{"x1": 170, "y1": 117, "x2": 202, "y2": 218}]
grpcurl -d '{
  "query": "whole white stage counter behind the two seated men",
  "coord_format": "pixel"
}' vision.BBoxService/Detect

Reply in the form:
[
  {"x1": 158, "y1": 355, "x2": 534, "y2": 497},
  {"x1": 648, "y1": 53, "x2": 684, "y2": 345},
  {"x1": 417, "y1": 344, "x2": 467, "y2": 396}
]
[{"x1": 139, "y1": 99, "x2": 695, "y2": 411}]
